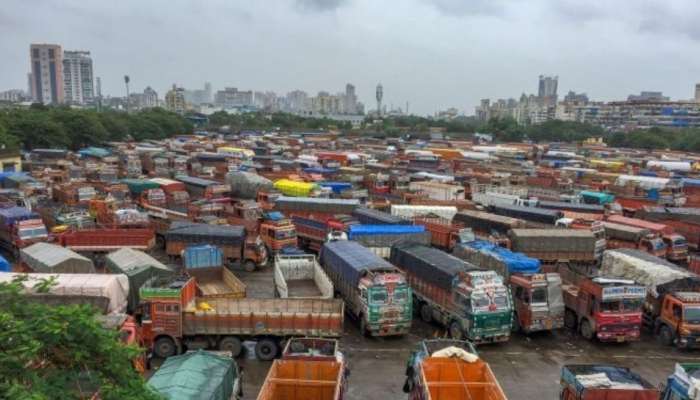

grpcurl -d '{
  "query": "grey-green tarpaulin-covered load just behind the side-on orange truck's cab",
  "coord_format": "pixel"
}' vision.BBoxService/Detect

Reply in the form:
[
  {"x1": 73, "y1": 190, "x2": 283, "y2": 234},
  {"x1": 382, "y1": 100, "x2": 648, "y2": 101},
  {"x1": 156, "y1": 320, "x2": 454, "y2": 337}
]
[{"x1": 105, "y1": 248, "x2": 175, "y2": 312}]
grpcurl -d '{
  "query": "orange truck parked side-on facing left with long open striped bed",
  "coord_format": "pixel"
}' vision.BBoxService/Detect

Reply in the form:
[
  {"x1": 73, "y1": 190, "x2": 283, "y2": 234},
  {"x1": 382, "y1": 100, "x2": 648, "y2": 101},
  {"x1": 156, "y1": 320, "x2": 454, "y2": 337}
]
[{"x1": 139, "y1": 278, "x2": 343, "y2": 361}]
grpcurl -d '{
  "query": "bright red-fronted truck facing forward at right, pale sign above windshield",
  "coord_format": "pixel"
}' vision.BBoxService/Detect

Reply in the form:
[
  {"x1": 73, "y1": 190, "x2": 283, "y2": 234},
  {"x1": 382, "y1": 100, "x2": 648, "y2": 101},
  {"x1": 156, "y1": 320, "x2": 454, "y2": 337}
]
[{"x1": 562, "y1": 277, "x2": 646, "y2": 342}]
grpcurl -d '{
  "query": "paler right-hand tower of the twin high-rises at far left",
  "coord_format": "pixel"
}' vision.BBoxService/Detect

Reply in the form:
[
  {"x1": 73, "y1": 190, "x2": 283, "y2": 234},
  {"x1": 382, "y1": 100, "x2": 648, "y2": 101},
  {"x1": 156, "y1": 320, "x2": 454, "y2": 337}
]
[{"x1": 63, "y1": 50, "x2": 95, "y2": 104}]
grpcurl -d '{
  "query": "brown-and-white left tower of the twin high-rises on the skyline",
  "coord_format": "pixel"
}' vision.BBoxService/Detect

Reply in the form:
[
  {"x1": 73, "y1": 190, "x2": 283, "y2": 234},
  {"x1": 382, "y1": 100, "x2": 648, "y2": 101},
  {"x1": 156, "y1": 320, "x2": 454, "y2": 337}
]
[{"x1": 29, "y1": 44, "x2": 63, "y2": 104}]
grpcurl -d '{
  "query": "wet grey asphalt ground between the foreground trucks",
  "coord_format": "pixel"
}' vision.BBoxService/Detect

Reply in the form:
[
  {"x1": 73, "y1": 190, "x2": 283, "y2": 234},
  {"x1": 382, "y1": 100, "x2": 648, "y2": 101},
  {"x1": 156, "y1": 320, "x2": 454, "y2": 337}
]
[{"x1": 239, "y1": 318, "x2": 700, "y2": 400}]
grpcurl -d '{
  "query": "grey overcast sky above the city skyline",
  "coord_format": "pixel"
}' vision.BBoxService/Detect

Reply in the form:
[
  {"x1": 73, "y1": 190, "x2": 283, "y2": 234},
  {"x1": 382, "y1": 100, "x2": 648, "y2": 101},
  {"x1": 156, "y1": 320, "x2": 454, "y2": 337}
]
[{"x1": 0, "y1": 0, "x2": 700, "y2": 115}]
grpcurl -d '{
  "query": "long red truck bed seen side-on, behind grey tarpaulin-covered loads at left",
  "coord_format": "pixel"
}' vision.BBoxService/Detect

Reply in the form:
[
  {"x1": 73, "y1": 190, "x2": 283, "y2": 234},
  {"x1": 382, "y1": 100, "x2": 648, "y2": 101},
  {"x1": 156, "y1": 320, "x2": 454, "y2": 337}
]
[{"x1": 57, "y1": 228, "x2": 155, "y2": 253}]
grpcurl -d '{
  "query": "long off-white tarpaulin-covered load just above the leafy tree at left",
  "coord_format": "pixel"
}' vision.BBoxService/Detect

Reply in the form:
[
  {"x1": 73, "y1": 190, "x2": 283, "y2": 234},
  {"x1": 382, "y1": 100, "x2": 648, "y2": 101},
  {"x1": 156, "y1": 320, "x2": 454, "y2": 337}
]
[{"x1": 0, "y1": 272, "x2": 129, "y2": 314}]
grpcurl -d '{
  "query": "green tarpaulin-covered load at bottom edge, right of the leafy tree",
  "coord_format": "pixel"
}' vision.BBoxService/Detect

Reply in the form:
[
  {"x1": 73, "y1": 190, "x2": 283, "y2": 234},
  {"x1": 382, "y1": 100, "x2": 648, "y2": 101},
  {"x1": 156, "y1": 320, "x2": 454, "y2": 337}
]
[{"x1": 148, "y1": 350, "x2": 242, "y2": 400}]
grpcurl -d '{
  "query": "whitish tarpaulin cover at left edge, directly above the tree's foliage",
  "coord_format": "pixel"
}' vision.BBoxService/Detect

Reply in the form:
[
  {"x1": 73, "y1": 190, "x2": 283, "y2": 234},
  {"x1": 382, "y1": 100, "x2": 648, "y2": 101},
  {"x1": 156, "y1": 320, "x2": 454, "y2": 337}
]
[{"x1": 0, "y1": 272, "x2": 129, "y2": 314}]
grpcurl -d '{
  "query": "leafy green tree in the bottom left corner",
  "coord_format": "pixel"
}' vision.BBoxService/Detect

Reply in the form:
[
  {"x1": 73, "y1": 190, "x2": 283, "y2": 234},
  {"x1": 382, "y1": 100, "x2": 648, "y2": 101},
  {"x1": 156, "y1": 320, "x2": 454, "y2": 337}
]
[{"x1": 0, "y1": 277, "x2": 160, "y2": 400}]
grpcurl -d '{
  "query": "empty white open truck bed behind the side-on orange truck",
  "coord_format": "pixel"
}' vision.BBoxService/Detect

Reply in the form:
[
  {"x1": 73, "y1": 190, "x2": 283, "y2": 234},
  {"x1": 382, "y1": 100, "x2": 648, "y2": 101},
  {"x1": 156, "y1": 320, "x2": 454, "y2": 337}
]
[{"x1": 274, "y1": 254, "x2": 333, "y2": 299}]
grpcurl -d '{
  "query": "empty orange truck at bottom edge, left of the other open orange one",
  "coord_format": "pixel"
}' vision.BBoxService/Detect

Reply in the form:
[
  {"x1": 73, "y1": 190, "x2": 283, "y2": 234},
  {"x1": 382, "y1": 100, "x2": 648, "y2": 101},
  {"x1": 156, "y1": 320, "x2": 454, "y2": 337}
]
[{"x1": 258, "y1": 338, "x2": 348, "y2": 400}]
